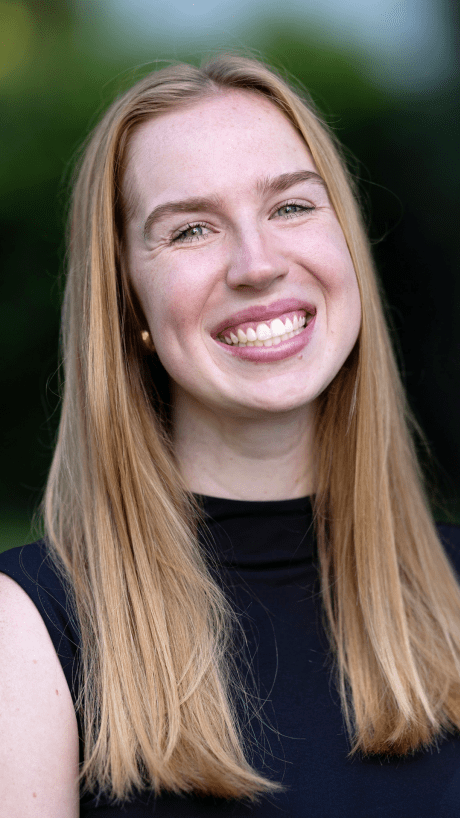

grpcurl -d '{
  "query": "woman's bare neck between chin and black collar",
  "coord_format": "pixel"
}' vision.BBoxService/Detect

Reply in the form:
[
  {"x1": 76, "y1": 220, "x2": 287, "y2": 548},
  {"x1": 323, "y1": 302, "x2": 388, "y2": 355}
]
[{"x1": 174, "y1": 392, "x2": 315, "y2": 500}]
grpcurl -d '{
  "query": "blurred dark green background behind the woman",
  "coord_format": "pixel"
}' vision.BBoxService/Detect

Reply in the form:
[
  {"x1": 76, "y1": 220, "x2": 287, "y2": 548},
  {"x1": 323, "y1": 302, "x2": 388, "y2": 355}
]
[{"x1": 0, "y1": 0, "x2": 460, "y2": 549}]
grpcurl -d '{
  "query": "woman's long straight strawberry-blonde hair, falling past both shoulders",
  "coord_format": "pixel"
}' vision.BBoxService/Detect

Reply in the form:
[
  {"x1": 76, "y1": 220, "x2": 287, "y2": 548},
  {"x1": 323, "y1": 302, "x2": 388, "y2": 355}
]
[{"x1": 44, "y1": 54, "x2": 460, "y2": 800}]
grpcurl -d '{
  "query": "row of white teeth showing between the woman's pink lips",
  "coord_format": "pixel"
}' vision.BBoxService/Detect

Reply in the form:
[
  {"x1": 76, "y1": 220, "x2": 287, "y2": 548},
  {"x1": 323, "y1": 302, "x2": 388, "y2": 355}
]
[{"x1": 217, "y1": 310, "x2": 313, "y2": 347}]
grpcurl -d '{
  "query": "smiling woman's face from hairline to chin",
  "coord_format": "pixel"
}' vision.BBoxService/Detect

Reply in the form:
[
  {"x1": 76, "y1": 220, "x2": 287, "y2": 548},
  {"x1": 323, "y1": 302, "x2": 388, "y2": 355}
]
[{"x1": 124, "y1": 90, "x2": 361, "y2": 417}]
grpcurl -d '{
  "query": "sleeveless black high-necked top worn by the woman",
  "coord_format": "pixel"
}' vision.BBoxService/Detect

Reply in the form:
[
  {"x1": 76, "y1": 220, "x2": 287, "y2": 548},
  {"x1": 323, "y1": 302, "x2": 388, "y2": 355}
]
[{"x1": 0, "y1": 497, "x2": 460, "y2": 818}]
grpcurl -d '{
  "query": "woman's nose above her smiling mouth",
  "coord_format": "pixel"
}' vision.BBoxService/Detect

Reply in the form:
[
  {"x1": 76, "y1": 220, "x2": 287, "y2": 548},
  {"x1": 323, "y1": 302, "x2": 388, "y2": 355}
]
[{"x1": 227, "y1": 227, "x2": 288, "y2": 290}]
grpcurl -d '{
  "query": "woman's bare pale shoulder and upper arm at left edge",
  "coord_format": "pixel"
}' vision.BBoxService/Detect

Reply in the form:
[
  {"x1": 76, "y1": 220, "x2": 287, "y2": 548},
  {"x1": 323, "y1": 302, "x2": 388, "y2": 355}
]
[{"x1": 0, "y1": 573, "x2": 79, "y2": 818}]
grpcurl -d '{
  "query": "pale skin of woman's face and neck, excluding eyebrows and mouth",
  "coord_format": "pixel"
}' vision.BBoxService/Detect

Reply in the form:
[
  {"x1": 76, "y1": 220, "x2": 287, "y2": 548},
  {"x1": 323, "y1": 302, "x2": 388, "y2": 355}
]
[{"x1": 124, "y1": 90, "x2": 361, "y2": 500}]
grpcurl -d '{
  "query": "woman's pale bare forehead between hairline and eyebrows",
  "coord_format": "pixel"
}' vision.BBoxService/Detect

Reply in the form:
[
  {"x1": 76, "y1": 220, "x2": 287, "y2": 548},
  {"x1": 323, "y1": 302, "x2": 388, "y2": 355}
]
[{"x1": 123, "y1": 89, "x2": 316, "y2": 217}]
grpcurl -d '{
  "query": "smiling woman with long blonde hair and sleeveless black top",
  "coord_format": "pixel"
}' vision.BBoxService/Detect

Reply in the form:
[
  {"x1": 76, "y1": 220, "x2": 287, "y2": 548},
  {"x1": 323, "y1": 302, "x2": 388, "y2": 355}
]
[{"x1": 0, "y1": 55, "x2": 460, "y2": 818}]
